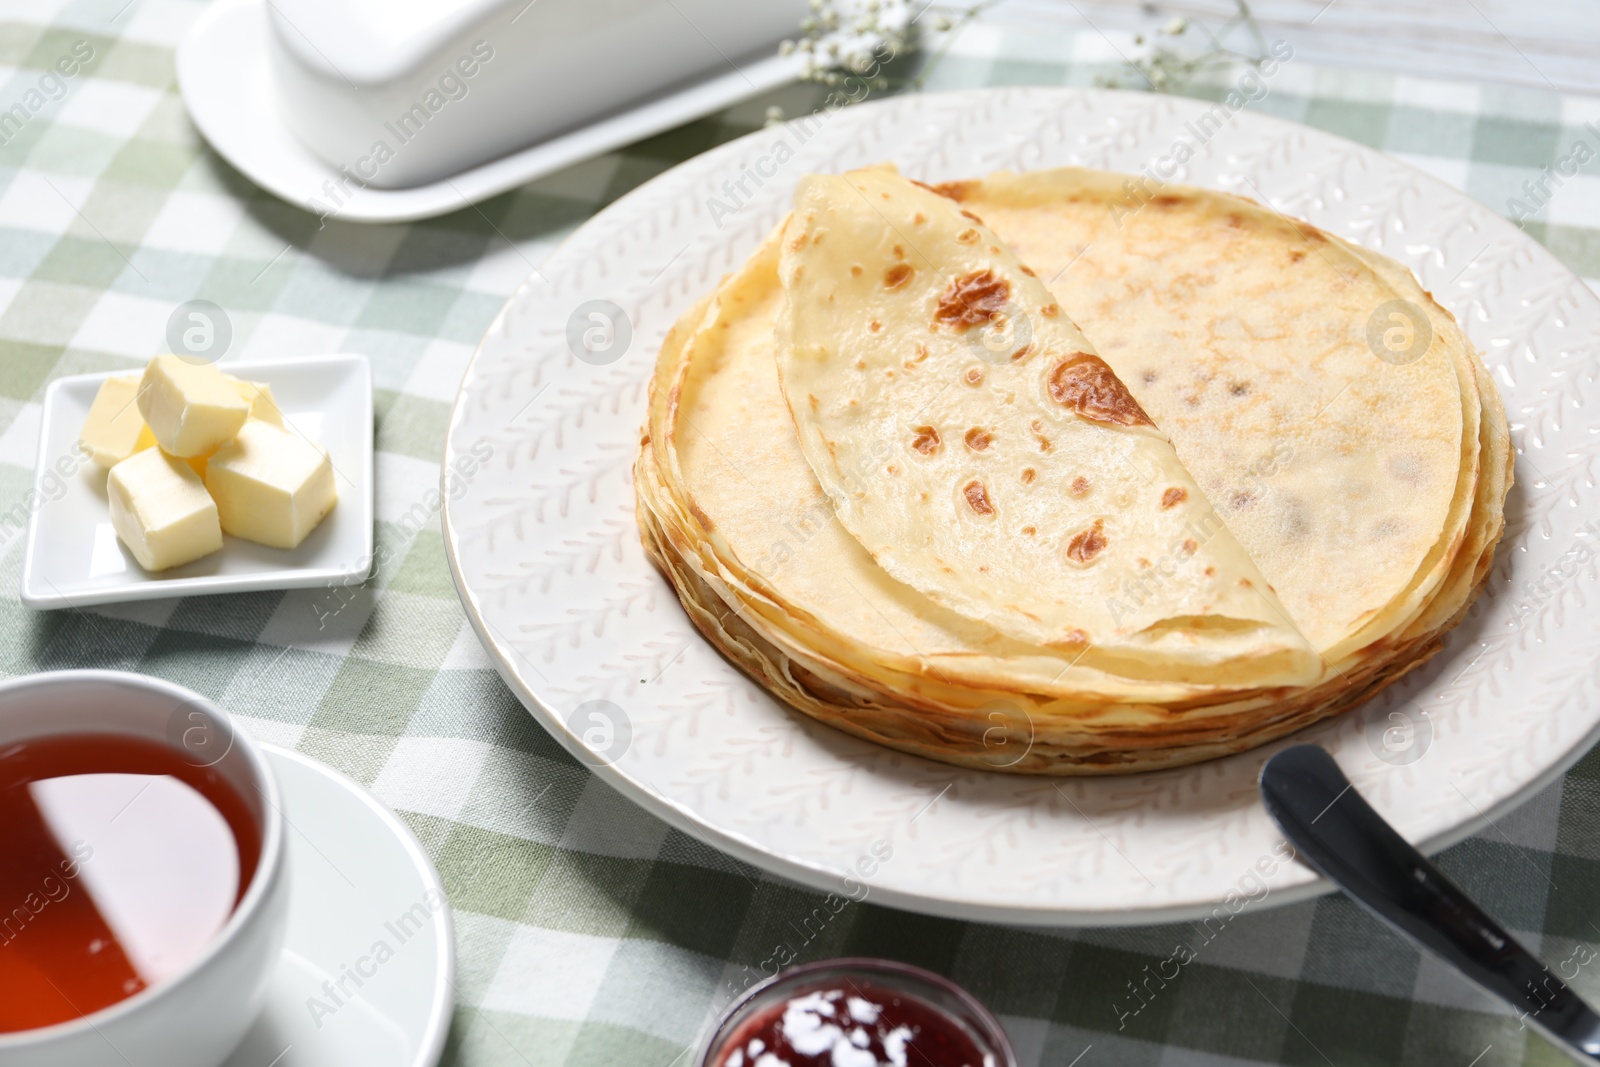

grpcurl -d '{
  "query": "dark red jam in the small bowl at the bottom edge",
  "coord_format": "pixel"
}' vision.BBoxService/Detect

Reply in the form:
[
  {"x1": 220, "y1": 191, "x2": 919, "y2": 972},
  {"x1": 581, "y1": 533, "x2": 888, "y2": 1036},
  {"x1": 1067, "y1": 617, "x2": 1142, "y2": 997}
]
[{"x1": 717, "y1": 982, "x2": 986, "y2": 1067}]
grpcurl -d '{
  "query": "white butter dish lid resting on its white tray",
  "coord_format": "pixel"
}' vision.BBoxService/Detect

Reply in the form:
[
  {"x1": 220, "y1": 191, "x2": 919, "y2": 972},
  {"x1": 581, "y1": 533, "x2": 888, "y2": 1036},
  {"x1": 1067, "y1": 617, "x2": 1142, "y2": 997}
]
[{"x1": 267, "y1": 0, "x2": 806, "y2": 189}]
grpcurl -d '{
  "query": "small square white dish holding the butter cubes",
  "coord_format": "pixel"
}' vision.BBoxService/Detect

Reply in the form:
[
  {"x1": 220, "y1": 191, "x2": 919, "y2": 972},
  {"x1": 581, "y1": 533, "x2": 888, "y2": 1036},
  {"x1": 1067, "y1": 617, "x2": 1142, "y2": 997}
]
[{"x1": 21, "y1": 355, "x2": 374, "y2": 609}]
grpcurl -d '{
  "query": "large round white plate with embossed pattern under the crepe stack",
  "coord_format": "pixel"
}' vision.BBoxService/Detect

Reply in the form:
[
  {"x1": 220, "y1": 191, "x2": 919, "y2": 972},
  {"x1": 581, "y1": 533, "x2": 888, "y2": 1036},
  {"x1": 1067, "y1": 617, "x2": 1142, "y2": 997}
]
[{"x1": 445, "y1": 88, "x2": 1600, "y2": 925}]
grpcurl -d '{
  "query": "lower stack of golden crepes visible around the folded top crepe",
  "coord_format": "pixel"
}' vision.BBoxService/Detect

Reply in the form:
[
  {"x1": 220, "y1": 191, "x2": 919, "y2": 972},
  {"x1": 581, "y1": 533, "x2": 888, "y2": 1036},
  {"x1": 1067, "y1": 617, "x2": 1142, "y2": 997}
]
[{"x1": 635, "y1": 160, "x2": 1510, "y2": 774}]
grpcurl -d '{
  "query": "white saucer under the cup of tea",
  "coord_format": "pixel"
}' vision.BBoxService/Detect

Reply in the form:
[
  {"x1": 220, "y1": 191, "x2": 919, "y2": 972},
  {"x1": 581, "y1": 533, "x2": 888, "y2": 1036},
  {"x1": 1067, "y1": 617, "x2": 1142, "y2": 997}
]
[{"x1": 222, "y1": 744, "x2": 456, "y2": 1067}]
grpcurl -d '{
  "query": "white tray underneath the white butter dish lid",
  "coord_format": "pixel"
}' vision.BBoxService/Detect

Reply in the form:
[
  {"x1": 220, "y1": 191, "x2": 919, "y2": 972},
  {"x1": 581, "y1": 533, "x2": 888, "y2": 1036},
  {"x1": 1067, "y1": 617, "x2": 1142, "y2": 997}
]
[{"x1": 178, "y1": 0, "x2": 798, "y2": 222}]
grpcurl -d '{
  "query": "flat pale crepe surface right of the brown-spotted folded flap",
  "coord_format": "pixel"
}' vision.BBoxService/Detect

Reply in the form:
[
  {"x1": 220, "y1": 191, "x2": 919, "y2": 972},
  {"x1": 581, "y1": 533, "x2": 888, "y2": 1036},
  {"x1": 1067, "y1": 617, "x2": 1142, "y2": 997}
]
[{"x1": 949, "y1": 168, "x2": 1477, "y2": 661}]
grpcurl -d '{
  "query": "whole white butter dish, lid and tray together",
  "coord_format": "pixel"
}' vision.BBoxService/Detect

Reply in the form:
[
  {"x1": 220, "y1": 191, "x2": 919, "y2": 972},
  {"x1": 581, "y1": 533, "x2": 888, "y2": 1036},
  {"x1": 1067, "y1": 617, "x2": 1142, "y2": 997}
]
[{"x1": 178, "y1": 0, "x2": 806, "y2": 222}]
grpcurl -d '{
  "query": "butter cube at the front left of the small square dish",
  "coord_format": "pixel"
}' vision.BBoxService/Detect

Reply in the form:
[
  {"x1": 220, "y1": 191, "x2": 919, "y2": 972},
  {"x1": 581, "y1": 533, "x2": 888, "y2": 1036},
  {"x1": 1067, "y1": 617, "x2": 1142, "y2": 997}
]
[{"x1": 106, "y1": 448, "x2": 222, "y2": 571}]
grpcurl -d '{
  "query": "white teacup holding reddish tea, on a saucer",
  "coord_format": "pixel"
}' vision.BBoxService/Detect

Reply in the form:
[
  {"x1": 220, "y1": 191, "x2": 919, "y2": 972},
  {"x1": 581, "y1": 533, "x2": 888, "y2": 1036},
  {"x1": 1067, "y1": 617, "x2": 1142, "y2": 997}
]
[{"x1": 0, "y1": 670, "x2": 290, "y2": 1067}]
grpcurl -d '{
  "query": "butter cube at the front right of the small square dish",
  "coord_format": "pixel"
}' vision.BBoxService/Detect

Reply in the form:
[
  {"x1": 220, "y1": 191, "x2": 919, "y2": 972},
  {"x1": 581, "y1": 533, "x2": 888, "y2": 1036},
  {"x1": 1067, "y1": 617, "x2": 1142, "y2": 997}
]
[{"x1": 205, "y1": 419, "x2": 338, "y2": 549}]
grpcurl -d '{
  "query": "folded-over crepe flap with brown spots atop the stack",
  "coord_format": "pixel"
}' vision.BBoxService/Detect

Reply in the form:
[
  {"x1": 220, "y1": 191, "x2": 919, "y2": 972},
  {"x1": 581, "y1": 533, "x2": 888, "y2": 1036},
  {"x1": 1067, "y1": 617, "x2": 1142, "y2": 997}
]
[{"x1": 778, "y1": 168, "x2": 1320, "y2": 685}]
